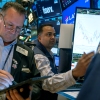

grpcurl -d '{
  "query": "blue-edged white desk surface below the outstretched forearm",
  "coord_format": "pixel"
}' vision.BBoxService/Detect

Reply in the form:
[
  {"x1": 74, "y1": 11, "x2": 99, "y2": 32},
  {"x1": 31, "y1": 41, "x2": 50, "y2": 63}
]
[{"x1": 58, "y1": 91, "x2": 79, "y2": 100}]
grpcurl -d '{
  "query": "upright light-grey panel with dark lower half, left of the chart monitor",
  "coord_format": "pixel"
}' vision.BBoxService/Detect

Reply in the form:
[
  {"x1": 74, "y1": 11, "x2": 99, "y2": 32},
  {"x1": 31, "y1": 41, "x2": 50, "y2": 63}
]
[{"x1": 58, "y1": 24, "x2": 74, "y2": 73}]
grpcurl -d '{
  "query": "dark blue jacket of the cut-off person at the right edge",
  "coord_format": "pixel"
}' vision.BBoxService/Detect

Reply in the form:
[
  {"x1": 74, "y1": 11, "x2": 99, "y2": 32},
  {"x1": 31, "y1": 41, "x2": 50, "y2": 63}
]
[{"x1": 76, "y1": 53, "x2": 100, "y2": 100}]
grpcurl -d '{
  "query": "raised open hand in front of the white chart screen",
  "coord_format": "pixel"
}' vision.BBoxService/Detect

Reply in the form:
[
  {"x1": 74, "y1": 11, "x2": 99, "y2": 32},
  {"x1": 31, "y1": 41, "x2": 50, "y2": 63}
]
[{"x1": 72, "y1": 52, "x2": 94, "y2": 78}]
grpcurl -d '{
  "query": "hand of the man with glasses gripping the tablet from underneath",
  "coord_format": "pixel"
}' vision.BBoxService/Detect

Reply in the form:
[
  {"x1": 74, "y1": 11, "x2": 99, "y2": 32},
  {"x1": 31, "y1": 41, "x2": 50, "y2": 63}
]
[{"x1": 6, "y1": 89, "x2": 31, "y2": 100}]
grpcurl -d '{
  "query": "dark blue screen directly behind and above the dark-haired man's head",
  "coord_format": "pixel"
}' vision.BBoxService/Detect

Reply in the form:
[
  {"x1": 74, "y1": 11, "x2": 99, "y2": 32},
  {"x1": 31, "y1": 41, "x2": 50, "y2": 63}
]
[{"x1": 38, "y1": 16, "x2": 62, "y2": 37}]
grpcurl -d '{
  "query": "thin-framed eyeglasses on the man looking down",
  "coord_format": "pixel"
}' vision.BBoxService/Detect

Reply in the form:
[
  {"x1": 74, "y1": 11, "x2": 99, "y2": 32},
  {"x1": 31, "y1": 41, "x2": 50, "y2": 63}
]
[{"x1": 0, "y1": 14, "x2": 23, "y2": 33}]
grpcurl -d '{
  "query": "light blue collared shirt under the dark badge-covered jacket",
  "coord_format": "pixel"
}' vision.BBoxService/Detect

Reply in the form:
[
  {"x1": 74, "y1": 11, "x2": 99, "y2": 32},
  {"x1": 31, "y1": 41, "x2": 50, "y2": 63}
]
[{"x1": 0, "y1": 37, "x2": 17, "y2": 100}]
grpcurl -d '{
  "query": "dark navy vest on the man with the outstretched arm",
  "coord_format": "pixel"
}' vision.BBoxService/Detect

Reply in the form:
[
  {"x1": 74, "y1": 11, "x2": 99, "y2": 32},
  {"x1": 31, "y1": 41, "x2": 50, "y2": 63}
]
[{"x1": 33, "y1": 41, "x2": 58, "y2": 100}]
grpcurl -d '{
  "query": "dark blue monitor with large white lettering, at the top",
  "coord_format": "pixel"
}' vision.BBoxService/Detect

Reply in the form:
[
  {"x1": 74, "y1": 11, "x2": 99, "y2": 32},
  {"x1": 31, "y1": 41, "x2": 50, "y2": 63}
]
[{"x1": 35, "y1": 0, "x2": 62, "y2": 18}]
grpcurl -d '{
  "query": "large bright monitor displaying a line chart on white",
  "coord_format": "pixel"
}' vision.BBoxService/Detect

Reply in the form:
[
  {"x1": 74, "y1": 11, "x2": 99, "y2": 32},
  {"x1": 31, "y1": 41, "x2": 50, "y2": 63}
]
[{"x1": 72, "y1": 8, "x2": 100, "y2": 67}]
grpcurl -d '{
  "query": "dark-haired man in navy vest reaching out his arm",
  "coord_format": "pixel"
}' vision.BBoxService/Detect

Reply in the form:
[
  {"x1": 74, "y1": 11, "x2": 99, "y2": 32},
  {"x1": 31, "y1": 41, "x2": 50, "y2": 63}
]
[{"x1": 33, "y1": 24, "x2": 94, "y2": 100}]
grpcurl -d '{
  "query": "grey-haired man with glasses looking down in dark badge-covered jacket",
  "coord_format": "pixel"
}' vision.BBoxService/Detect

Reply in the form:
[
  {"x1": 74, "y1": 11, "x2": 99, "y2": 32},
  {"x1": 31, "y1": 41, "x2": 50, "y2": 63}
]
[{"x1": 0, "y1": 2, "x2": 41, "y2": 100}]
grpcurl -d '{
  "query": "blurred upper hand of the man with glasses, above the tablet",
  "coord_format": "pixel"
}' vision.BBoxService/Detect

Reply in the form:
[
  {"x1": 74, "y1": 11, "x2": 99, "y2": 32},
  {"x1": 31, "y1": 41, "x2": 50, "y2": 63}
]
[{"x1": 0, "y1": 70, "x2": 14, "y2": 90}]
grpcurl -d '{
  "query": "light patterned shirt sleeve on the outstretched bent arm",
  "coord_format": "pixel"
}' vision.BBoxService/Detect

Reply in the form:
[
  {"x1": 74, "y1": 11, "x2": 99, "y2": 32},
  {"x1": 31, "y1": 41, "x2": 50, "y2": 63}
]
[{"x1": 35, "y1": 54, "x2": 76, "y2": 93}]
